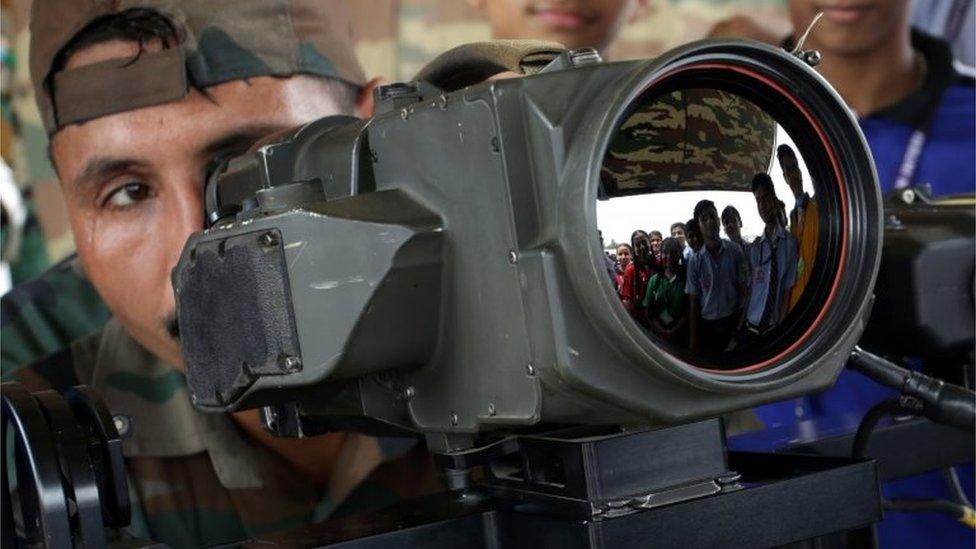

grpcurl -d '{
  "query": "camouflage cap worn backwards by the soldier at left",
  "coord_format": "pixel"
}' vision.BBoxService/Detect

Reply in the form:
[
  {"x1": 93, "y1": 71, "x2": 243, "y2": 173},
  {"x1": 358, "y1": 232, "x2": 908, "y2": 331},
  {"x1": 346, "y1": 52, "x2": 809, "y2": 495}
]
[{"x1": 30, "y1": 0, "x2": 366, "y2": 134}]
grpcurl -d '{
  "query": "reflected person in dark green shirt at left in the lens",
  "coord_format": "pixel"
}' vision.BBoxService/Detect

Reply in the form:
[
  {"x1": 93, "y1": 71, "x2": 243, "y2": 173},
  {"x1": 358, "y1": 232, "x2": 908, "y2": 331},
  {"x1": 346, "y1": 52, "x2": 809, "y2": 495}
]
[{"x1": 643, "y1": 237, "x2": 688, "y2": 346}]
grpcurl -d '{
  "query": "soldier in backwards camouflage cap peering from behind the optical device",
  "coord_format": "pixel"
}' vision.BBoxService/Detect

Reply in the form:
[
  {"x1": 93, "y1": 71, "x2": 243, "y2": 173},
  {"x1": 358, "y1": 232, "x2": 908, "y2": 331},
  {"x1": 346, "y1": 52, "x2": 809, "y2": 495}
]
[{"x1": 3, "y1": 0, "x2": 446, "y2": 547}]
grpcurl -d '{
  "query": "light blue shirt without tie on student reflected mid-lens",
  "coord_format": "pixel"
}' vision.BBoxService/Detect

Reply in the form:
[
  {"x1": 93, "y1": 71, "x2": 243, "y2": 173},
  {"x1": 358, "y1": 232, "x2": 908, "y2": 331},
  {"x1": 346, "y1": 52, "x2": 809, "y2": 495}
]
[{"x1": 685, "y1": 238, "x2": 746, "y2": 320}]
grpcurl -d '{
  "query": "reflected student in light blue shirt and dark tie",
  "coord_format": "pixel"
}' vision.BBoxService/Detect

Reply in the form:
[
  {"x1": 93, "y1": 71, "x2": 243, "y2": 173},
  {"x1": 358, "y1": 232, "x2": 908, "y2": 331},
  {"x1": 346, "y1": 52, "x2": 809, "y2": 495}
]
[{"x1": 746, "y1": 173, "x2": 797, "y2": 335}]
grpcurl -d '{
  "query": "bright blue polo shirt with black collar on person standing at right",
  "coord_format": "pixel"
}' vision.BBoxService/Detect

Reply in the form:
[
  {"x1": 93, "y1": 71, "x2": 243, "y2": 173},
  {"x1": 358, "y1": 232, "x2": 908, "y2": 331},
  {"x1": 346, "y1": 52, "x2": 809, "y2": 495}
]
[{"x1": 756, "y1": 27, "x2": 976, "y2": 548}]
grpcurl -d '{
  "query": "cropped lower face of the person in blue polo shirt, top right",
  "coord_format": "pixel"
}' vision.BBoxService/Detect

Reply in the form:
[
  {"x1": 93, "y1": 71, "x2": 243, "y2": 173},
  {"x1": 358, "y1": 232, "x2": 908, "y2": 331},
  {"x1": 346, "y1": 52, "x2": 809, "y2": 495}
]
[{"x1": 790, "y1": 0, "x2": 909, "y2": 55}]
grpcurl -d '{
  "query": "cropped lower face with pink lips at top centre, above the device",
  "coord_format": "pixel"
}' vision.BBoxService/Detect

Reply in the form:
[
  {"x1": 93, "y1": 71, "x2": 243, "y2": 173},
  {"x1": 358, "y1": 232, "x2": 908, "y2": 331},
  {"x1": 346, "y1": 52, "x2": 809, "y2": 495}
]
[{"x1": 469, "y1": 0, "x2": 643, "y2": 50}]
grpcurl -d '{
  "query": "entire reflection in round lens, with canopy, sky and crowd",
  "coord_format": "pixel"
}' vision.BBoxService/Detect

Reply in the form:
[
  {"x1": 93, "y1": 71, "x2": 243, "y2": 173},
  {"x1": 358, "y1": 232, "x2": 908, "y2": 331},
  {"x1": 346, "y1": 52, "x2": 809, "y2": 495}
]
[{"x1": 598, "y1": 88, "x2": 820, "y2": 369}]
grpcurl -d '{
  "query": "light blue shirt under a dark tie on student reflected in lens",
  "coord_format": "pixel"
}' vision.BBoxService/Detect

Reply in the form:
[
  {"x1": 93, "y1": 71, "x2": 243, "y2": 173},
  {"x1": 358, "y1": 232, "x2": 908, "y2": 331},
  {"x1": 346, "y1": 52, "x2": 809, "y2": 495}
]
[{"x1": 746, "y1": 226, "x2": 799, "y2": 326}]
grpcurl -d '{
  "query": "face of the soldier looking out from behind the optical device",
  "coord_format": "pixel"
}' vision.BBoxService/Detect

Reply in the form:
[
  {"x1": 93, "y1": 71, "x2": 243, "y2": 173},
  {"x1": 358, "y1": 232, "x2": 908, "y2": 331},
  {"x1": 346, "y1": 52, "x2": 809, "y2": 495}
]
[{"x1": 51, "y1": 42, "x2": 371, "y2": 367}]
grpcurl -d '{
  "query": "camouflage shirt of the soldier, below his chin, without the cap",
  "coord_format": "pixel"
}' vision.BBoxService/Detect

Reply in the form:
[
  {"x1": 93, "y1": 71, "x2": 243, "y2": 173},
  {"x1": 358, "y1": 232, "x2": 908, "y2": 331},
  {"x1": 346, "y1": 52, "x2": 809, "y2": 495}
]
[{"x1": 3, "y1": 314, "x2": 442, "y2": 547}]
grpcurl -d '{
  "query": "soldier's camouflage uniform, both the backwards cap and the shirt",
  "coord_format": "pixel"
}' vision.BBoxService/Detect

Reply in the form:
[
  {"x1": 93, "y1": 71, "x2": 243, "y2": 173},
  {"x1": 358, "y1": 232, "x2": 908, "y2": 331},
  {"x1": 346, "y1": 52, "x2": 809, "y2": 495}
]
[{"x1": 0, "y1": 0, "x2": 441, "y2": 547}]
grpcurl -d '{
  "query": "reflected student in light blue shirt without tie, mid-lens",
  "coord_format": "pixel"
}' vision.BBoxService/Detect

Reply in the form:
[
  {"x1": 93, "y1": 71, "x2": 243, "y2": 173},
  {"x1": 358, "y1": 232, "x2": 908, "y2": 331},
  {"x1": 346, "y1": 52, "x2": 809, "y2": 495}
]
[{"x1": 685, "y1": 200, "x2": 747, "y2": 353}]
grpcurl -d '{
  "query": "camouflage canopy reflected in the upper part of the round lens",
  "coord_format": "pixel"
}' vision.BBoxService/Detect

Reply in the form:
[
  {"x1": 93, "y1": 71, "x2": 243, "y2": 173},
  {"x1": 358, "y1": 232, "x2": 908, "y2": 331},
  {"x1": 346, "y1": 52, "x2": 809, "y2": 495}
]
[{"x1": 601, "y1": 89, "x2": 776, "y2": 196}]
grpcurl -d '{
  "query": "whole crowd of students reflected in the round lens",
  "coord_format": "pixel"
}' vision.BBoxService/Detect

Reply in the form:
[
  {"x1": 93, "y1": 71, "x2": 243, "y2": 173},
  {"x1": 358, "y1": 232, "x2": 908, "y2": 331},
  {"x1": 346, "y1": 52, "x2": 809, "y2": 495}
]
[{"x1": 606, "y1": 145, "x2": 818, "y2": 355}]
